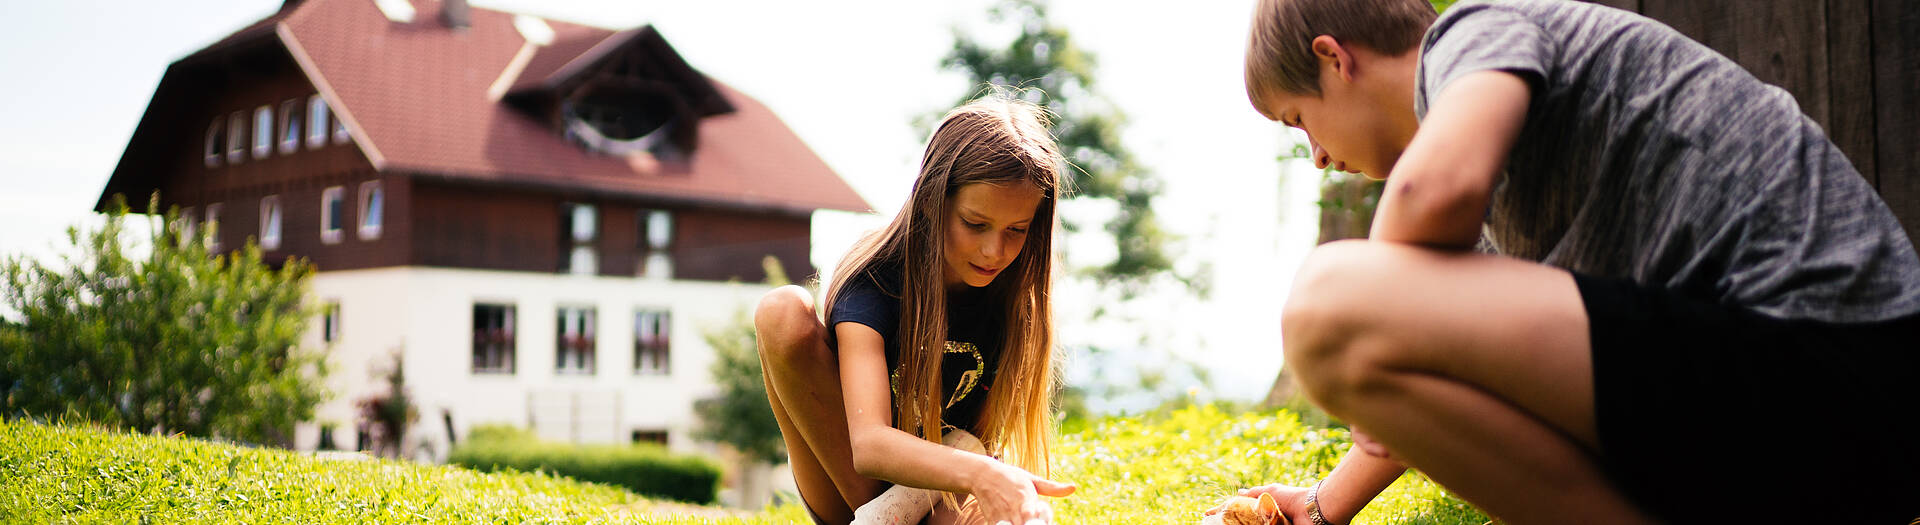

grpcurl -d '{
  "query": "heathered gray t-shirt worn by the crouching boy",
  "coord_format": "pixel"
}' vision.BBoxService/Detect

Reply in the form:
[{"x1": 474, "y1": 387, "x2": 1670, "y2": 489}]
[{"x1": 1415, "y1": 0, "x2": 1920, "y2": 323}]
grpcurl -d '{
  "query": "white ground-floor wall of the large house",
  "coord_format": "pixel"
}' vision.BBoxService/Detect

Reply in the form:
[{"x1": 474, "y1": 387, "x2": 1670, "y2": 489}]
[{"x1": 296, "y1": 267, "x2": 768, "y2": 456}]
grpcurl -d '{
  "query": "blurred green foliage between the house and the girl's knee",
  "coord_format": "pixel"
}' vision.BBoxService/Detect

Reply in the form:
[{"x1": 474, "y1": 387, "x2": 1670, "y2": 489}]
[{"x1": 693, "y1": 256, "x2": 787, "y2": 463}]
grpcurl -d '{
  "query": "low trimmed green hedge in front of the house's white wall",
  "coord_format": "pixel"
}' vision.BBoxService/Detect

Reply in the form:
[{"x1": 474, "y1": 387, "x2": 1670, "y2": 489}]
[{"x1": 447, "y1": 425, "x2": 720, "y2": 504}]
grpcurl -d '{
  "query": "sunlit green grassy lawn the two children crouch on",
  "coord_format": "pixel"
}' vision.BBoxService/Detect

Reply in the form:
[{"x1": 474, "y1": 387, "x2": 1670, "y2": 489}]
[{"x1": 0, "y1": 408, "x2": 1488, "y2": 525}]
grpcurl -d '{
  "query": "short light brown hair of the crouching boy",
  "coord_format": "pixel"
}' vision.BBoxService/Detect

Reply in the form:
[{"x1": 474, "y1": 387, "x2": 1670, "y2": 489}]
[{"x1": 1246, "y1": 0, "x2": 1438, "y2": 106}]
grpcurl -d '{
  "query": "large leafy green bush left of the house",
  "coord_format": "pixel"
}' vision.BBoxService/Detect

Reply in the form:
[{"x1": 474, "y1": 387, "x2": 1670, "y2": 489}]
[{"x1": 0, "y1": 194, "x2": 324, "y2": 444}]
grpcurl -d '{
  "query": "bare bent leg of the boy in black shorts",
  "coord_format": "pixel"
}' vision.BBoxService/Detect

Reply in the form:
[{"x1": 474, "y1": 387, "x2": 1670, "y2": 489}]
[{"x1": 1283, "y1": 242, "x2": 1651, "y2": 523}]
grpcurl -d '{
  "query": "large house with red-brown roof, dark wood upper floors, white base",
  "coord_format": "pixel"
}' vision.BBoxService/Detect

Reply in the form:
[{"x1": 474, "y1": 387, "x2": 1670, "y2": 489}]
[{"x1": 100, "y1": 0, "x2": 868, "y2": 456}]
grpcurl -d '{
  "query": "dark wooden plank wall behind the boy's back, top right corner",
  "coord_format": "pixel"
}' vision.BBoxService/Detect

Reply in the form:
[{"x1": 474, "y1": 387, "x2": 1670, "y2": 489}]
[{"x1": 1594, "y1": 0, "x2": 1920, "y2": 248}]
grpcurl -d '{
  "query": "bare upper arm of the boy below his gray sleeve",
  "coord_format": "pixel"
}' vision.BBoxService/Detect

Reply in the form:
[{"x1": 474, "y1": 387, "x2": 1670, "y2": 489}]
[{"x1": 1371, "y1": 71, "x2": 1530, "y2": 250}]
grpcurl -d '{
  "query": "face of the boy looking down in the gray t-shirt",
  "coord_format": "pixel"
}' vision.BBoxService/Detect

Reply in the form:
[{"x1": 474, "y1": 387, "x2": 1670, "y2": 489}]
[{"x1": 1256, "y1": 37, "x2": 1413, "y2": 179}]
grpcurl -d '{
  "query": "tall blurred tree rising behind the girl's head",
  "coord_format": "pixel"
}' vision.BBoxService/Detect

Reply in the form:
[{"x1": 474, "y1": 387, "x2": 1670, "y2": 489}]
[{"x1": 941, "y1": 0, "x2": 1206, "y2": 298}]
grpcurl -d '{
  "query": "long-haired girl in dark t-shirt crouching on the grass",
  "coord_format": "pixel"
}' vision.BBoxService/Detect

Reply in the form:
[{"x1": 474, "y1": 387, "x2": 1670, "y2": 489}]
[{"x1": 755, "y1": 96, "x2": 1073, "y2": 523}]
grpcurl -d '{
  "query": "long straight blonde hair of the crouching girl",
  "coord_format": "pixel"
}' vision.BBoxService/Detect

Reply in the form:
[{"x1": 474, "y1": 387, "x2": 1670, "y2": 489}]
[{"x1": 820, "y1": 94, "x2": 1066, "y2": 477}]
